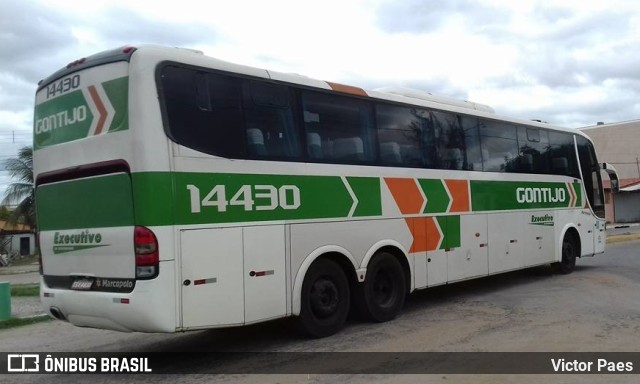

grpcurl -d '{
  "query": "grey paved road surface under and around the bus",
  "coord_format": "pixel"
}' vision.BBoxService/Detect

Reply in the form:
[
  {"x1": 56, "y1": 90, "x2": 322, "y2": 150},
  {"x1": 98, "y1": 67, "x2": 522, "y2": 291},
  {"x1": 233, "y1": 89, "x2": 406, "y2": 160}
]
[{"x1": 0, "y1": 241, "x2": 640, "y2": 383}]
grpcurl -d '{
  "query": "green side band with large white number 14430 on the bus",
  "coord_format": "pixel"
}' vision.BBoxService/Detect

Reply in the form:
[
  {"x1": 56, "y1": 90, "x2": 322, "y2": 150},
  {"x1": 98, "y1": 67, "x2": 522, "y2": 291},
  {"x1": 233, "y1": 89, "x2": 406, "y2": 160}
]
[{"x1": 174, "y1": 172, "x2": 356, "y2": 224}]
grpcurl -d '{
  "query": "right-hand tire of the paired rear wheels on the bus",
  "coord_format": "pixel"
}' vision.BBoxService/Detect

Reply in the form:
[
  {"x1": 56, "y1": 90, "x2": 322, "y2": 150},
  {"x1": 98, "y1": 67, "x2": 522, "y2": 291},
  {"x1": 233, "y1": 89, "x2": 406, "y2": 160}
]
[{"x1": 355, "y1": 252, "x2": 407, "y2": 323}]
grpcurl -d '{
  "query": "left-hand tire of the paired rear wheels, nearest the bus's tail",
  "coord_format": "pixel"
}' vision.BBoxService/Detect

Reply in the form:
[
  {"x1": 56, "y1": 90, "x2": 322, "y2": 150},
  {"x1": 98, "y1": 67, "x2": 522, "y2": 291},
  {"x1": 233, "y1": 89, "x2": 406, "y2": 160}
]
[{"x1": 298, "y1": 259, "x2": 351, "y2": 338}]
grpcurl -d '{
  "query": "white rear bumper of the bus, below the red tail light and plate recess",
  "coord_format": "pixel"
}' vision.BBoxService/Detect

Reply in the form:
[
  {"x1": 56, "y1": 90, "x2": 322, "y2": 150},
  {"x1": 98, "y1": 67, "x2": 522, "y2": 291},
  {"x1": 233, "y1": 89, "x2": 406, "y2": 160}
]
[{"x1": 40, "y1": 261, "x2": 177, "y2": 332}]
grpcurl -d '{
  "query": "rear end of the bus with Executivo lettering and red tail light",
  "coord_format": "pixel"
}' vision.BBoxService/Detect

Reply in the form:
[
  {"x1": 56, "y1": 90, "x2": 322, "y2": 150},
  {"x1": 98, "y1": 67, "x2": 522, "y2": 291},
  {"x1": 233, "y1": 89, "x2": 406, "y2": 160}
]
[{"x1": 34, "y1": 48, "x2": 176, "y2": 332}]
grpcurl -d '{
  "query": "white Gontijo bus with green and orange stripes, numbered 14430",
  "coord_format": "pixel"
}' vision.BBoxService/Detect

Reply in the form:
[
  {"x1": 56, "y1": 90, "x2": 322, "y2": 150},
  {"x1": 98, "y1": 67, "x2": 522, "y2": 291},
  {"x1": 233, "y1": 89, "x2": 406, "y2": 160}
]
[{"x1": 34, "y1": 46, "x2": 615, "y2": 337}]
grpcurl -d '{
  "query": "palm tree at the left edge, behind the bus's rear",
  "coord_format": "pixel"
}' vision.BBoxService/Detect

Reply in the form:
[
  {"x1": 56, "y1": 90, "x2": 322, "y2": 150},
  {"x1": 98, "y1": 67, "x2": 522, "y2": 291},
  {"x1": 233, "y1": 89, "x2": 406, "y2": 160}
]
[{"x1": 2, "y1": 147, "x2": 36, "y2": 229}]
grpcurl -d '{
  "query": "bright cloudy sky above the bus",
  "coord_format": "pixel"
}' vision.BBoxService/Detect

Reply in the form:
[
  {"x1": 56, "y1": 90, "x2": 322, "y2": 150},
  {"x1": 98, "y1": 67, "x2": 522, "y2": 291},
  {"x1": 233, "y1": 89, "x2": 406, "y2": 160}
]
[{"x1": 0, "y1": 0, "x2": 640, "y2": 198}]
